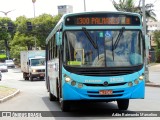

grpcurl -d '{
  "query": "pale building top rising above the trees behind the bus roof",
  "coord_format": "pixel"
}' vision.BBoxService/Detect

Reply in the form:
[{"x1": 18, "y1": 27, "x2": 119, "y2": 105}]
[{"x1": 58, "y1": 5, "x2": 73, "y2": 15}]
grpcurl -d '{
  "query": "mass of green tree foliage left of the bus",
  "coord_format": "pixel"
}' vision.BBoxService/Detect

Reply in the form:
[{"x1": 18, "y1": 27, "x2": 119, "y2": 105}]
[{"x1": 0, "y1": 14, "x2": 61, "y2": 62}]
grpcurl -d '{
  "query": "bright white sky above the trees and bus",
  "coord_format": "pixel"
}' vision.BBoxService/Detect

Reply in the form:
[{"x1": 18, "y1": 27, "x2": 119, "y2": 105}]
[{"x1": 0, "y1": 0, "x2": 160, "y2": 21}]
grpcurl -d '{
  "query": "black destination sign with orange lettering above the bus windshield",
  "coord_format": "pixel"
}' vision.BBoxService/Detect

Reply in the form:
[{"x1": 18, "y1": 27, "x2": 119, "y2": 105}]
[{"x1": 65, "y1": 14, "x2": 140, "y2": 26}]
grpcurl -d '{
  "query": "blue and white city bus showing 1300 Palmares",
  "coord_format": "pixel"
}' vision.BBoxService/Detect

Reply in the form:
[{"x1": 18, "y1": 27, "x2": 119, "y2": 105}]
[{"x1": 46, "y1": 12, "x2": 145, "y2": 111}]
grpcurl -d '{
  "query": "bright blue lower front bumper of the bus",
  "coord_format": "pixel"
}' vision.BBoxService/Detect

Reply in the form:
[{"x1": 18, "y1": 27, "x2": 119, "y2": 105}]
[{"x1": 63, "y1": 81, "x2": 145, "y2": 101}]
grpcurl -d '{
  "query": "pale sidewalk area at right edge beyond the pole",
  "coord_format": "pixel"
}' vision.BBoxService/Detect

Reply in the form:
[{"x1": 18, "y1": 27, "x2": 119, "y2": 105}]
[{"x1": 146, "y1": 63, "x2": 160, "y2": 87}]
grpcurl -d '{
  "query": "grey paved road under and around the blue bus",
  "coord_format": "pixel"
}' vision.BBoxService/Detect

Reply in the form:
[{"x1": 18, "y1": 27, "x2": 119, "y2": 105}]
[{"x1": 0, "y1": 69, "x2": 160, "y2": 120}]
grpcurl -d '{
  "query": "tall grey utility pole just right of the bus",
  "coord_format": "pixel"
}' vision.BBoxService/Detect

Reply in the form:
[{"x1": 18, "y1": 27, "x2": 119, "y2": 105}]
[{"x1": 142, "y1": 0, "x2": 149, "y2": 82}]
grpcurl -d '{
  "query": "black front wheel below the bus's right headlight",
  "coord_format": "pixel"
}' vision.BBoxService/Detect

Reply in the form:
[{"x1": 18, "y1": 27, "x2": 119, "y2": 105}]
[{"x1": 117, "y1": 99, "x2": 129, "y2": 110}]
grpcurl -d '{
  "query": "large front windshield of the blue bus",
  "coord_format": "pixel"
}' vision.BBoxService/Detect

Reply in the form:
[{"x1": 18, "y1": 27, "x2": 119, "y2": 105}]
[{"x1": 64, "y1": 29, "x2": 144, "y2": 67}]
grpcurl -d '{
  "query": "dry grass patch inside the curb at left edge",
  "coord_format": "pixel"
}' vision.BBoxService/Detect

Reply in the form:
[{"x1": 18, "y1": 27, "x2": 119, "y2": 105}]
[{"x1": 0, "y1": 85, "x2": 17, "y2": 99}]
